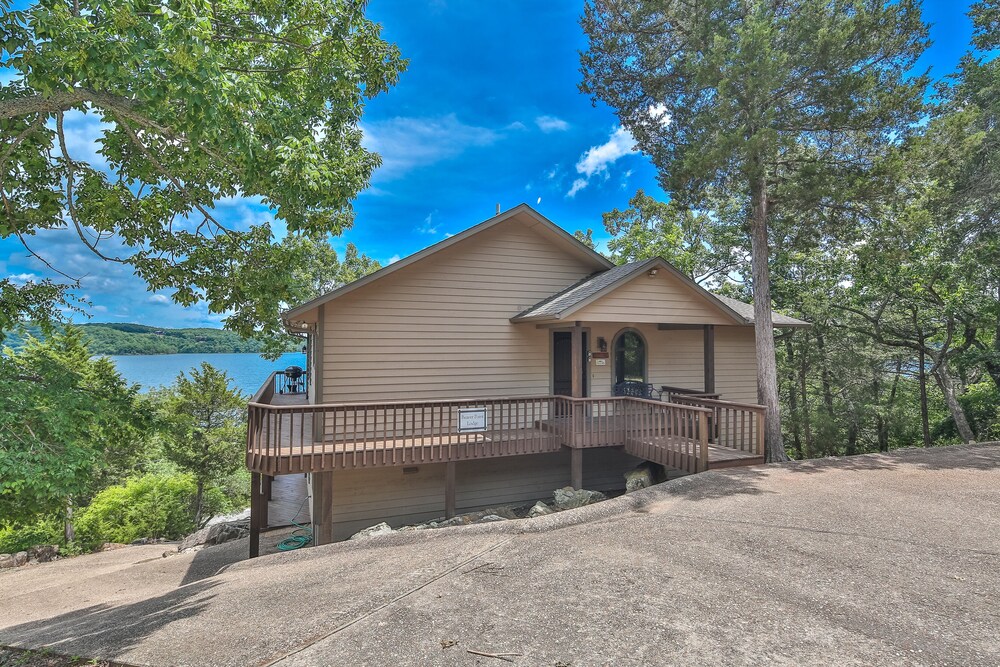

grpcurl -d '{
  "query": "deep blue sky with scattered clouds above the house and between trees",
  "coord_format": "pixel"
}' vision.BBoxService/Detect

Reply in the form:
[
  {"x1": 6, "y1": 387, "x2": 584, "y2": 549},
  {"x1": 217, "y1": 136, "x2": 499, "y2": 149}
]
[{"x1": 0, "y1": 0, "x2": 971, "y2": 327}]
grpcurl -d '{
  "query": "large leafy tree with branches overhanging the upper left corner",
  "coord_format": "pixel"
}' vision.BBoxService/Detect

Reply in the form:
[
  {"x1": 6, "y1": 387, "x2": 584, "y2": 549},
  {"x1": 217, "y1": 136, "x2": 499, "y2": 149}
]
[{"x1": 0, "y1": 0, "x2": 405, "y2": 336}]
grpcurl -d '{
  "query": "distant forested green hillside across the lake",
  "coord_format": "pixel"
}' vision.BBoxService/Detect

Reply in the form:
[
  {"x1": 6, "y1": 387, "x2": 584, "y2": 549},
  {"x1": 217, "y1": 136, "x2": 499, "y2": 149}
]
[{"x1": 5, "y1": 323, "x2": 297, "y2": 355}]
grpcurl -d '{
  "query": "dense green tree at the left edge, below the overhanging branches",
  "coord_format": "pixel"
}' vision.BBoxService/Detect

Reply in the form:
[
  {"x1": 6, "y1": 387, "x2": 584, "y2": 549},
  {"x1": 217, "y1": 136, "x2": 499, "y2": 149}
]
[{"x1": 0, "y1": 327, "x2": 150, "y2": 537}]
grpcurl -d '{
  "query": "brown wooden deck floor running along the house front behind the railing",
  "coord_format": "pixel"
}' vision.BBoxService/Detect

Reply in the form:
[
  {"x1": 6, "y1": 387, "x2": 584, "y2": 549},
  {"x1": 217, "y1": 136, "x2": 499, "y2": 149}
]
[{"x1": 247, "y1": 394, "x2": 763, "y2": 476}]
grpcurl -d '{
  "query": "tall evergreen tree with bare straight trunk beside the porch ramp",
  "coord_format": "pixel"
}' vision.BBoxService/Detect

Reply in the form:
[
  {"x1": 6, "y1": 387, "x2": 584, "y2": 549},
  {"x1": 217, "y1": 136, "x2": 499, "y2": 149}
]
[{"x1": 581, "y1": 0, "x2": 928, "y2": 461}]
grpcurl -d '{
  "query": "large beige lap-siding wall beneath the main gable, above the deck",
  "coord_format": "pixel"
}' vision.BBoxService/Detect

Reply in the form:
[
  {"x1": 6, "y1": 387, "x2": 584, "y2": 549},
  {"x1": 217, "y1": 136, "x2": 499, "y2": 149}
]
[{"x1": 322, "y1": 219, "x2": 599, "y2": 403}]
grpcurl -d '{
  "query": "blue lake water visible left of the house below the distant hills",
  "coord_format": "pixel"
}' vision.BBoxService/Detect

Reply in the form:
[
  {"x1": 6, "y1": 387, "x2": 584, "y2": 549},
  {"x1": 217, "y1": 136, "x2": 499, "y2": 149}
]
[{"x1": 108, "y1": 352, "x2": 306, "y2": 397}]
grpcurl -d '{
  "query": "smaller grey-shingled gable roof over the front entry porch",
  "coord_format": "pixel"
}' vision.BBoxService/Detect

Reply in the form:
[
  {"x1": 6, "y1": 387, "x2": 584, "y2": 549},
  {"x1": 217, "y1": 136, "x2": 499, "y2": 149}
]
[{"x1": 511, "y1": 257, "x2": 809, "y2": 327}]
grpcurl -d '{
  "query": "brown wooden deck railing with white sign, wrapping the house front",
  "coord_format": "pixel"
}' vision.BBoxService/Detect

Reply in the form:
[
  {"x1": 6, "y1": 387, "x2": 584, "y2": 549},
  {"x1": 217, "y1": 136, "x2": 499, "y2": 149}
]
[{"x1": 247, "y1": 386, "x2": 764, "y2": 475}]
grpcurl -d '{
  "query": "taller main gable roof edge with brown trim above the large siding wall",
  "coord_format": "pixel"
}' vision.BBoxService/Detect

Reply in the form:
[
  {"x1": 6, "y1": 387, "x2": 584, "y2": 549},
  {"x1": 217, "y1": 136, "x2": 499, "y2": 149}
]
[{"x1": 281, "y1": 204, "x2": 615, "y2": 324}]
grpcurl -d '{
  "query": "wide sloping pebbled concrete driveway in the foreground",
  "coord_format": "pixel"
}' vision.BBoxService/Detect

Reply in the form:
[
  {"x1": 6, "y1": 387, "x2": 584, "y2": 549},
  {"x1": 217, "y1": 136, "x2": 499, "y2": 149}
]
[{"x1": 0, "y1": 445, "x2": 1000, "y2": 667}]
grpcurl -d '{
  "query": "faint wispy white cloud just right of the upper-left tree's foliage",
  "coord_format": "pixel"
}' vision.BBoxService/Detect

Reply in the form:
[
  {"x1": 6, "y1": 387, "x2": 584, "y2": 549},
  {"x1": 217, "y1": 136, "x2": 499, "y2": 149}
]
[{"x1": 362, "y1": 114, "x2": 500, "y2": 181}]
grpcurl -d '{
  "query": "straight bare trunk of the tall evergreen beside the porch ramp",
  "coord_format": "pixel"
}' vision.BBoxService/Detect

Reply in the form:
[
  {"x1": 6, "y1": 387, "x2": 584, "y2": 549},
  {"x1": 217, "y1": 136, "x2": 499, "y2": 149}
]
[{"x1": 750, "y1": 176, "x2": 788, "y2": 463}]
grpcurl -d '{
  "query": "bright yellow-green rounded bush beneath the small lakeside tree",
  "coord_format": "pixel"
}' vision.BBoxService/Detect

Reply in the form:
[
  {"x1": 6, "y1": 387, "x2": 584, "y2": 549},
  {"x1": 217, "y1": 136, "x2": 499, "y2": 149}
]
[{"x1": 76, "y1": 474, "x2": 225, "y2": 547}]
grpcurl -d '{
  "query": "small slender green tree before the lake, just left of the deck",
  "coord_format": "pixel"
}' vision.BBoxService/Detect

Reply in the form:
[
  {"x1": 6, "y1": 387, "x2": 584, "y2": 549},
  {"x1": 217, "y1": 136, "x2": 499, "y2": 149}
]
[{"x1": 159, "y1": 362, "x2": 246, "y2": 526}]
